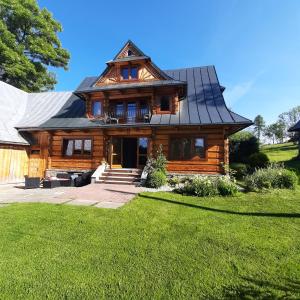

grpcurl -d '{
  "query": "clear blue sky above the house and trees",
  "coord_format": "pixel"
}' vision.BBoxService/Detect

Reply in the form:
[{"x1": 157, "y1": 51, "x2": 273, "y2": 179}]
[{"x1": 38, "y1": 0, "x2": 300, "y2": 123}]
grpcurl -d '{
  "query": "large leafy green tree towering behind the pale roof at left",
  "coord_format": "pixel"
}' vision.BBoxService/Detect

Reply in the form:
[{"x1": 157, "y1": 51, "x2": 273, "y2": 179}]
[{"x1": 0, "y1": 0, "x2": 70, "y2": 92}]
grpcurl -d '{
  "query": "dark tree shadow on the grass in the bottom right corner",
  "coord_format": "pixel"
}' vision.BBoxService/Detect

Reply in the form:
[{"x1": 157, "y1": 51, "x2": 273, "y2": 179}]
[{"x1": 224, "y1": 277, "x2": 300, "y2": 299}]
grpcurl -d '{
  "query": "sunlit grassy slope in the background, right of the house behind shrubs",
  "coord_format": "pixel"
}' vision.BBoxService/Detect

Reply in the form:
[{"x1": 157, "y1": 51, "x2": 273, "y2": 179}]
[{"x1": 262, "y1": 143, "x2": 300, "y2": 178}]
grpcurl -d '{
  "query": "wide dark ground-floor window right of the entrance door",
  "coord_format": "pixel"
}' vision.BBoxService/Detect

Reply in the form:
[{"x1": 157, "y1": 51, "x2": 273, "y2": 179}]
[{"x1": 169, "y1": 137, "x2": 206, "y2": 160}]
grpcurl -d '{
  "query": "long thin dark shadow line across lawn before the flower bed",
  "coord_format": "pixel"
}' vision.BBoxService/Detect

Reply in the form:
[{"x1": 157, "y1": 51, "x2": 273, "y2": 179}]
[{"x1": 140, "y1": 195, "x2": 300, "y2": 218}]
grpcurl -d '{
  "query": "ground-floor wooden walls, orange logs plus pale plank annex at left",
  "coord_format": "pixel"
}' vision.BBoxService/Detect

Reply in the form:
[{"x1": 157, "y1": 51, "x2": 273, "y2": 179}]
[{"x1": 0, "y1": 126, "x2": 229, "y2": 183}]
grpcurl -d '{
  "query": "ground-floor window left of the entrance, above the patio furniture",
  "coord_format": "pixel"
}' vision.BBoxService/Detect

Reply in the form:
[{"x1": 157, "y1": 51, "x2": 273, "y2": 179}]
[{"x1": 62, "y1": 138, "x2": 92, "y2": 157}]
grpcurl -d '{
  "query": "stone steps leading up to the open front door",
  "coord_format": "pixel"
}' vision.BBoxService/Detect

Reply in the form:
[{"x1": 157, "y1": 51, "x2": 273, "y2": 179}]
[{"x1": 96, "y1": 168, "x2": 142, "y2": 184}]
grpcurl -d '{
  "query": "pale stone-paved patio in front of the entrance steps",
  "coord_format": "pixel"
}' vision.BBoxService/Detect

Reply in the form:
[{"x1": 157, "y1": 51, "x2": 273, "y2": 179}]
[{"x1": 0, "y1": 184, "x2": 143, "y2": 209}]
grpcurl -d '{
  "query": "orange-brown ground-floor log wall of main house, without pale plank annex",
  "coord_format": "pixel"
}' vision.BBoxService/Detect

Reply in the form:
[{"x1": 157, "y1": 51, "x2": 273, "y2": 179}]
[{"x1": 30, "y1": 126, "x2": 228, "y2": 174}]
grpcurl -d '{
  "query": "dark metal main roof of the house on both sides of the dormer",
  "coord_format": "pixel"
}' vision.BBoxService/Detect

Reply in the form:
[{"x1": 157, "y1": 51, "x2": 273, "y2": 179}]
[{"x1": 40, "y1": 66, "x2": 252, "y2": 129}]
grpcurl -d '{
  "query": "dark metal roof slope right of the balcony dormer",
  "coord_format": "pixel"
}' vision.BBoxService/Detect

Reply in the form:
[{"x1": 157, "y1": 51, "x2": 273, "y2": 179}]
[{"x1": 151, "y1": 66, "x2": 252, "y2": 126}]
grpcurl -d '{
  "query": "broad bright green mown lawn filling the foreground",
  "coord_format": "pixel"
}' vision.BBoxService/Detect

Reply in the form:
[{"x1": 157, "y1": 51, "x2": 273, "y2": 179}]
[{"x1": 0, "y1": 189, "x2": 300, "y2": 299}]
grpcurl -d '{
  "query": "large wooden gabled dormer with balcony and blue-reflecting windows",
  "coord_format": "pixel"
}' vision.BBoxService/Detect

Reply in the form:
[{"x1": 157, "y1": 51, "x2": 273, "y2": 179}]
[{"x1": 77, "y1": 41, "x2": 187, "y2": 123}]
